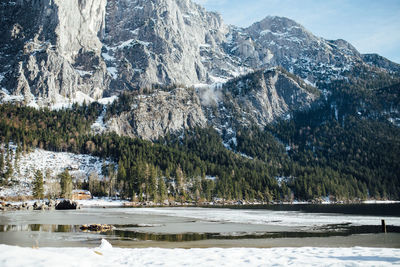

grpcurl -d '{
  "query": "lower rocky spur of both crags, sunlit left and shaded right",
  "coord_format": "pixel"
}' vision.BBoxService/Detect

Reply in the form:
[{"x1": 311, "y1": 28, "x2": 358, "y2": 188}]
[{"x1": 106, "y1": 68, "x2": 319, "y2": 140}]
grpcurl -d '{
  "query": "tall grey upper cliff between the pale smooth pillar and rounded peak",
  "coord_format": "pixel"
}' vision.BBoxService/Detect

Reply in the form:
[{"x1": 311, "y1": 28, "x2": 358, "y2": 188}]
[{"x1": 103, "y1": 0, "x2": 245, "y2": 90}]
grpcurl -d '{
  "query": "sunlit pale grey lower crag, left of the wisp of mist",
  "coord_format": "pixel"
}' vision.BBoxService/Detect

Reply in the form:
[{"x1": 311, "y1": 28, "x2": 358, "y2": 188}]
[{"x1": 107, "y1": 88, "x2": 207, "y2": 140}]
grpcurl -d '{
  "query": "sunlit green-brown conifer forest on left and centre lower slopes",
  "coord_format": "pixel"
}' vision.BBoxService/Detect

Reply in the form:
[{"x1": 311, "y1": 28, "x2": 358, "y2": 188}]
[{"x1": 0, "y1": 104, "x2": 281, "y2": 201}]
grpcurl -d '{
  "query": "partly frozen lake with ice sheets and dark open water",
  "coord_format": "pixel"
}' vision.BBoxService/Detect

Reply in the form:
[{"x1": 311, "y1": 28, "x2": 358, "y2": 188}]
[{"x1": 0, "y1": 207, "x2": 400, "y2": 248}]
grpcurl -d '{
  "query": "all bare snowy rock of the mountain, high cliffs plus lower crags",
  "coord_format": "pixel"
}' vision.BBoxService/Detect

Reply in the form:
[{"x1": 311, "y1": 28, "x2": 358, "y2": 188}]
[{"x1": 0, "y1": 0, "x2": 400, "y2": 139}]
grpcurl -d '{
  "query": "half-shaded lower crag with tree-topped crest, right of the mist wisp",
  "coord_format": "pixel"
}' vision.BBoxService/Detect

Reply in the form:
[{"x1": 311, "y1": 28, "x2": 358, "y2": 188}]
[{"x1": 203, "y1": 68, "x2": 319, "y2": 148}]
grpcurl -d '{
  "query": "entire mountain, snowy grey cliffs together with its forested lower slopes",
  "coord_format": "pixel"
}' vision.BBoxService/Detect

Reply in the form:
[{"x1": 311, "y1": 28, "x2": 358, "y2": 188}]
[{"x1": 0, "y1": 0, "x2": 400, "y2": 201}]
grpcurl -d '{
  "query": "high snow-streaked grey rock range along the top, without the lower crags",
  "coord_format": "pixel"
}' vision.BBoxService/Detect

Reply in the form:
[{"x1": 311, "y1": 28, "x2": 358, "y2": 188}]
[{"x1": 0, "y1": 0, "x2": 394, "y2": 108}]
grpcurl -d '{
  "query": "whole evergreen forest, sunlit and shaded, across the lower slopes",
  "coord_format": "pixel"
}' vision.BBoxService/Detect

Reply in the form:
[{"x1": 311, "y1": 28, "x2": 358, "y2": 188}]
[{"x1": 0, "y1": 72, "x2": 400, "y2": 201}]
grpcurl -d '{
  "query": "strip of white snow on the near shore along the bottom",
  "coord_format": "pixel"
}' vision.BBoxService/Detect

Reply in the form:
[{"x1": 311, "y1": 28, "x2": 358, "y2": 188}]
[{"x1": 0, "y1": 239, "x2": 400, "y2": 267}]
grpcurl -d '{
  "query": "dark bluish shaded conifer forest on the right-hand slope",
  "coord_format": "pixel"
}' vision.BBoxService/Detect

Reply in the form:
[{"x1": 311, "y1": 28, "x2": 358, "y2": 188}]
[{"x1": 265, "y1": 87, "x2": 400, "y2": 199}]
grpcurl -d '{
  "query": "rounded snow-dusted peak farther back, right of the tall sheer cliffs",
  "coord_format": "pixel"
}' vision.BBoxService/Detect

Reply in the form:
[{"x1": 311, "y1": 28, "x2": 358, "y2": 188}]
[{"x1": 227, "y1": 17, "x2": 363, "y2": 83}]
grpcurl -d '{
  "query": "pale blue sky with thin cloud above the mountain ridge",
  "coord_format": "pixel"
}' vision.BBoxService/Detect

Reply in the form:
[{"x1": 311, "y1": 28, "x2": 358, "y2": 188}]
[{"x1": 194, "y1": 0, "x2": 400, "y2": 63}]
